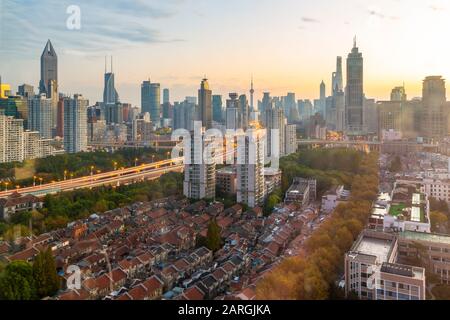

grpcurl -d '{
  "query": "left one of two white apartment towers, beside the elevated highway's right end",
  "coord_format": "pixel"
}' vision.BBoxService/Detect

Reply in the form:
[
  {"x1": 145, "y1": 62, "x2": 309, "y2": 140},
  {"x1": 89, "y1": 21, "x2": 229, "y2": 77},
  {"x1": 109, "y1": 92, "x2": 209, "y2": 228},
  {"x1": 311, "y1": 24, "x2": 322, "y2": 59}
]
[{"x1": 183, "y1": 127, "x2": 216, "y2": 199}]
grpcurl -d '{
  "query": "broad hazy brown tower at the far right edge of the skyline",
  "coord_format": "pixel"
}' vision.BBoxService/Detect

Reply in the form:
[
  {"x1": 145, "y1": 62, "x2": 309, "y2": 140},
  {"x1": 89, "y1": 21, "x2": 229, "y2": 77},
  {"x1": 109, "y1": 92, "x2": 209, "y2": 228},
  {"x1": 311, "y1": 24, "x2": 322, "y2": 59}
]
[{"x1": 421, "y1": 76, "x2": 448, "y2": 139}]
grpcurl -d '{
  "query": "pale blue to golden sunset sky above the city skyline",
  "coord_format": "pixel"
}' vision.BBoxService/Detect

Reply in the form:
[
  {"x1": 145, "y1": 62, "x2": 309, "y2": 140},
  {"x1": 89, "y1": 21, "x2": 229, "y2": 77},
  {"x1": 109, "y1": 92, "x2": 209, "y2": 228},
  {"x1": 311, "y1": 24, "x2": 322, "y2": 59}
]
[{"x1": 0, "y1": 0, "x2": 450, "y2": 106}]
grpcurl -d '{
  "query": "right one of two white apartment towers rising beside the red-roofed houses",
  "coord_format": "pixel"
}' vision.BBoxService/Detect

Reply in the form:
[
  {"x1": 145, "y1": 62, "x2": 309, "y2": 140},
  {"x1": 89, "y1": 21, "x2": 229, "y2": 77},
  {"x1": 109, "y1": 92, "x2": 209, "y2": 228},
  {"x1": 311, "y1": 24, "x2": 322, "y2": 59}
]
[{"x1": 236, "y1": 126, "x2": 266, "y2": 208}]
